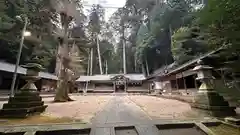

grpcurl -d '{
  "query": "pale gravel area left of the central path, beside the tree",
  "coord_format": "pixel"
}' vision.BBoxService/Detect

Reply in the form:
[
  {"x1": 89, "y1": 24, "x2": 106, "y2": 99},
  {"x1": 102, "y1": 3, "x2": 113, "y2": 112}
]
[{"x1": 43, "y1": 96, "x2": 112, "y2": 123}]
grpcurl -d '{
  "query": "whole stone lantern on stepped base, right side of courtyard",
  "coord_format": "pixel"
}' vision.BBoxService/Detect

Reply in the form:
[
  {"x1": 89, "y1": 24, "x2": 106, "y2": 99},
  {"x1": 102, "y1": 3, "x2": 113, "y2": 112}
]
[{"x1": 191, "y1": 60, "x2": 236, "y2": 116}]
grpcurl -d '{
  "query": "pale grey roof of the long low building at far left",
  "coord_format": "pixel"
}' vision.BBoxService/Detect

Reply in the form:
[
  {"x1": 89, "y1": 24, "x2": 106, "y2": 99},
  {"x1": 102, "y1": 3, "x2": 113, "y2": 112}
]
[{"x1": 0, "y1": 61, "x2": 58, "y2": 80}]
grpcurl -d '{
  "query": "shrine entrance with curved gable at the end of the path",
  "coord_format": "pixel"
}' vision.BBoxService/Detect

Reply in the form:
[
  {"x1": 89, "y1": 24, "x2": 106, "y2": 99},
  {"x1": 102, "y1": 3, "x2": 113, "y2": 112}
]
[{"x1": 111, "y1": 75, "x2": 129, "y2": 92}]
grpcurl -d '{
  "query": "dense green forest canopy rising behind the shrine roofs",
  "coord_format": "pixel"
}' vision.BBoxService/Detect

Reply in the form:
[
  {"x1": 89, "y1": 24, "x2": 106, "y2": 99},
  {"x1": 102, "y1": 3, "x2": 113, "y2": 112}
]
[{"x1": 0, "y1": 0, "x2": 240, "y2": 77}]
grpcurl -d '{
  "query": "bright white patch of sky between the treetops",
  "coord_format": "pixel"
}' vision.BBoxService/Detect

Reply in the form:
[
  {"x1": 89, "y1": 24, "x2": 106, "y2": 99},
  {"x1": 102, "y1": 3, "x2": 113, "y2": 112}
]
[{"x1": 84, "y1": 0, "x2": 126, "y2": 21}]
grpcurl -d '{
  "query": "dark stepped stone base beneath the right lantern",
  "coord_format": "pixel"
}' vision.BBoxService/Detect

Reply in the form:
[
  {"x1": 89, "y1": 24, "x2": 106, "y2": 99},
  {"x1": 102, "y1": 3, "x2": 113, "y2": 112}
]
[{"x1": 191, "y1": 91, "x2": 236, "y2": 117}]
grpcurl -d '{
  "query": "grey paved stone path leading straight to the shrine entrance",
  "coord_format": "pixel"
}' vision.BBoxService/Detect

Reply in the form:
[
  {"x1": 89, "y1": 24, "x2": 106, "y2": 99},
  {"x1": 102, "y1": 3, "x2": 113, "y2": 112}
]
[{"x1": 92, "y1": 96, "x2": 150, "y2": 124}]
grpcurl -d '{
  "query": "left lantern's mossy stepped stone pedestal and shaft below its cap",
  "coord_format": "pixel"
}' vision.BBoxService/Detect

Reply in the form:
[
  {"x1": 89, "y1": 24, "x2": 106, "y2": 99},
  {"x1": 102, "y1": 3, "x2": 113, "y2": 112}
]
[{"x1": 0, "y1": 70, "x2": 47, "y2": 118}]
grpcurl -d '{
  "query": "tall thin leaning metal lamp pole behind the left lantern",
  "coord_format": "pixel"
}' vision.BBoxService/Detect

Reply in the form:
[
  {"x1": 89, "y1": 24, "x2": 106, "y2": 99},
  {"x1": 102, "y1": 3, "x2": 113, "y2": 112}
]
[{"x1": 10, "y1": 17, "x2": 27, "y2": 97}]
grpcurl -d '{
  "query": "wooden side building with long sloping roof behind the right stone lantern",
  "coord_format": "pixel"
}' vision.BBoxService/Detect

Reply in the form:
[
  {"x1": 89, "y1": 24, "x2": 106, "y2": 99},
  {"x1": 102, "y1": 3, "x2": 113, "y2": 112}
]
[{"x1": 146, "y1": 48, "x2": 228, "y2": 94}]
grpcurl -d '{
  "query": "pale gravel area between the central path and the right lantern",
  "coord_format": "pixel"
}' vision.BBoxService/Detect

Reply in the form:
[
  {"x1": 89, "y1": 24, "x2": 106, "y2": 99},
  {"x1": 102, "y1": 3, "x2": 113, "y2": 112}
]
[{"x1": 129, "y1": 96, "x2": 204, "y2": 119}]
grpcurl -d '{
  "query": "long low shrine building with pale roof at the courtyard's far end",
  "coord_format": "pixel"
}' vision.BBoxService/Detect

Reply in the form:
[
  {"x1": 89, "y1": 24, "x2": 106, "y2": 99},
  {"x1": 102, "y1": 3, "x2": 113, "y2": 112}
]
[{"x1": 76, "y1": 74, "x2": 149, "y2": 93}]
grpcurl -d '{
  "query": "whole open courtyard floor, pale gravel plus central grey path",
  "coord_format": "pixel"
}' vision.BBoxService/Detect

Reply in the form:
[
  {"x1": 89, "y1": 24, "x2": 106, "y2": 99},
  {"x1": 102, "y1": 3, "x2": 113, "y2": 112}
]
[{"x1": 1, "y1": 94, "x2": 208, "y2": 124}]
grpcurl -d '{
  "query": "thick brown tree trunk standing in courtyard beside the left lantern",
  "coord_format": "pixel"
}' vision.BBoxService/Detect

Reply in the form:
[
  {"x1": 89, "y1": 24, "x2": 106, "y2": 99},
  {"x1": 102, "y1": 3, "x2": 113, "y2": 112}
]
[{"x1": 54, "y1": 17, "x2": 72, "y2": 102}]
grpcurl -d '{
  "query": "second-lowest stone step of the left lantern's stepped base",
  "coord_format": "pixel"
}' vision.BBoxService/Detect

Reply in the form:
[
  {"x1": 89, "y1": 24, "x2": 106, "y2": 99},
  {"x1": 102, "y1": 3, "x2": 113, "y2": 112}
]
[{"x1": 3, "y1": 101, "x2": 44, "y2": 109}]
